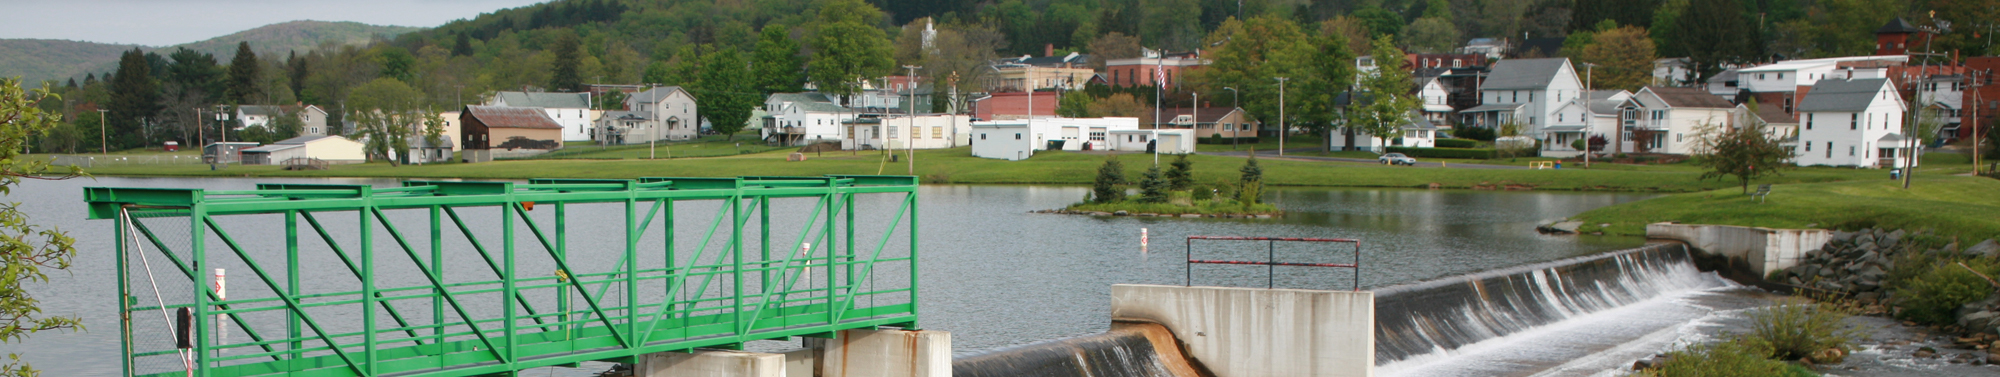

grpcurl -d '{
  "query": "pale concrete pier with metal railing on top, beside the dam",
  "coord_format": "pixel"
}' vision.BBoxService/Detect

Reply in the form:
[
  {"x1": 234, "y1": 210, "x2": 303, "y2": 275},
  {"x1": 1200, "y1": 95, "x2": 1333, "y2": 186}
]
[{"x1": 1112, "y1": 285, "x2": 1374, "y2": 377}]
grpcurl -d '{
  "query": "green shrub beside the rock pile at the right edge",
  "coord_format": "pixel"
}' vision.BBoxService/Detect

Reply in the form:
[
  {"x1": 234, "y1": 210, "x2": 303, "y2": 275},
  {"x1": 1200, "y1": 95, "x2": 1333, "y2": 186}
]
[{"x1": 1894, "y1": 259, "x2": 1994, "y2": 325}]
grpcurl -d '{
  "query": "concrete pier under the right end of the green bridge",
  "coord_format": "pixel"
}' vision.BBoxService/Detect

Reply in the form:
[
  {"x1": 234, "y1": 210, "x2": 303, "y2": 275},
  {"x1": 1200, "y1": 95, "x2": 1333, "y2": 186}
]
[{"x1": 820, "y1": 329, "x2": 952, "y2": 377}]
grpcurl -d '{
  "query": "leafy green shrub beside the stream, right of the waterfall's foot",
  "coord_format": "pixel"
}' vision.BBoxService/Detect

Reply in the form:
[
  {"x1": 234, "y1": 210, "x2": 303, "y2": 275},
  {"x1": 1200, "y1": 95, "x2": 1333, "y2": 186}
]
[{"x1": 1742, "y1": 299, "x2": 1860, "y2": 363}]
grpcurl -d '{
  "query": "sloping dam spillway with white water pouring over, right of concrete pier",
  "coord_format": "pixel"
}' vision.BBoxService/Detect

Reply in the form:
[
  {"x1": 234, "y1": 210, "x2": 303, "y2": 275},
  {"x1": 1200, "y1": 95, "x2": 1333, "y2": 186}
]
[{"x1": 1374, "y1": 245, "x2": 1728, "y2": 365}]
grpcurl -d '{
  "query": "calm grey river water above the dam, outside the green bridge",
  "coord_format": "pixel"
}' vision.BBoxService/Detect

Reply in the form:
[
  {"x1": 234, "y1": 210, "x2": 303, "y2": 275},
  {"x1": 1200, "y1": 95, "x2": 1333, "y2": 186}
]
[{"x1": 0, "y1": 178, "x2": 1652, "y2": 375}]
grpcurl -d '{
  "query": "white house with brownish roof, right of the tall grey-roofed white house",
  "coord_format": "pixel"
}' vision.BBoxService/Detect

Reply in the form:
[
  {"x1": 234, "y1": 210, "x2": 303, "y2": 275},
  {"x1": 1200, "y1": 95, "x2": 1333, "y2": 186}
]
[{"x1": 1612, "y1": 86, "x2": 1736, "y2": 154}]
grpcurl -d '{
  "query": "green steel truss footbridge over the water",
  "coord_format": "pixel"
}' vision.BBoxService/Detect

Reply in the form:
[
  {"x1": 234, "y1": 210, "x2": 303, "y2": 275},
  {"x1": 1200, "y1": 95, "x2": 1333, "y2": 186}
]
[{"x1": 86, "y1": 176, "x2": 918, "y2": 377}]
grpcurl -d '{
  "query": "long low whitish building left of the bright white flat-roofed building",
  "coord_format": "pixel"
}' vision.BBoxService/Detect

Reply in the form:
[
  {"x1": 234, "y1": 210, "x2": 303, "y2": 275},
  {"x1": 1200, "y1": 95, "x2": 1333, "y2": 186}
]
[{"x1": 840, "y1": 114, "x2": 972, "y2": 150}]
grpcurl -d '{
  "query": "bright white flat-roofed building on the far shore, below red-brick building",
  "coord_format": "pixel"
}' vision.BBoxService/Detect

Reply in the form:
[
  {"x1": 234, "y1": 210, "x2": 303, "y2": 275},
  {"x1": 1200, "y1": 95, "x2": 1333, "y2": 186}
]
[{"x1": 972, "y1": 118, "x2": 1144, "y2": 160}]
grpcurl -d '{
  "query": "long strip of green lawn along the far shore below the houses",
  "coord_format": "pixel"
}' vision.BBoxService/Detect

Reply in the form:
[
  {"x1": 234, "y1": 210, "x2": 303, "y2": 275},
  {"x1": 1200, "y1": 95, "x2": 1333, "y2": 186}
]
[{"x1": 58, "y1": 148, "x2": 1952, "y2": 193}]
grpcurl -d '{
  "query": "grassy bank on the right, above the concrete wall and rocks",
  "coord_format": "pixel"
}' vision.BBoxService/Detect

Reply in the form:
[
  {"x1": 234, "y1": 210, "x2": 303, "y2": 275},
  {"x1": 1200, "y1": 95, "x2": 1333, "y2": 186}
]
[{"x1": 1572, "y1": 174, "x2": 2000, "y2": 239}]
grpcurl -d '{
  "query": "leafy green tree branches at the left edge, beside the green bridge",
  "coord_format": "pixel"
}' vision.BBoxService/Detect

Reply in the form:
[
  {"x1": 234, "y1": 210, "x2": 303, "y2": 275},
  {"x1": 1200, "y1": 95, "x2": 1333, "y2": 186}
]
[{"x1": 0, "y1": 77, "x2": 84, "y2": 377}]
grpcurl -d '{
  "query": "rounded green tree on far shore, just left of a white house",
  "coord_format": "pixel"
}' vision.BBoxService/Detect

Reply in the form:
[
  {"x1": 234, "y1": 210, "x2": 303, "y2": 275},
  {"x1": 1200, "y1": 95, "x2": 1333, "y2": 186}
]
[{"x1": 692, "y1": 48, "x2": 764, "y2": 138}]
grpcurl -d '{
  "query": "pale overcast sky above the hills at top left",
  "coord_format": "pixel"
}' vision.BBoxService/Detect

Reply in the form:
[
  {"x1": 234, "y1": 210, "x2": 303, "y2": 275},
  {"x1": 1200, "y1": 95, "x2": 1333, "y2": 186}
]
[{"x1": 0, "y1": 0, "x2": 544, "y2": 46}]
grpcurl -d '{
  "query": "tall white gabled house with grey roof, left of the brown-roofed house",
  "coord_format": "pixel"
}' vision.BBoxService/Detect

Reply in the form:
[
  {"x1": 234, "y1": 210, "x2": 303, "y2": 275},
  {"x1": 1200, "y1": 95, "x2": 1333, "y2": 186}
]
[{"x1": 1460, "y1": 58, "x2": 1584, "y2": 134}]
